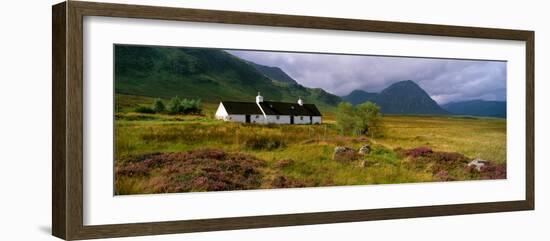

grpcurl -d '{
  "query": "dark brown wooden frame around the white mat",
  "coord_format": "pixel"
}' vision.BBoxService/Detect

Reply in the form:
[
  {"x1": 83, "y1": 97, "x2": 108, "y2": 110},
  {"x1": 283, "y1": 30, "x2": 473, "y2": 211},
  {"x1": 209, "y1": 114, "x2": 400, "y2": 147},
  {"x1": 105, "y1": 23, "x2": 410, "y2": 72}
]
[{"x1": 52, "y1": 1, "x2": 535, "y2": 240}]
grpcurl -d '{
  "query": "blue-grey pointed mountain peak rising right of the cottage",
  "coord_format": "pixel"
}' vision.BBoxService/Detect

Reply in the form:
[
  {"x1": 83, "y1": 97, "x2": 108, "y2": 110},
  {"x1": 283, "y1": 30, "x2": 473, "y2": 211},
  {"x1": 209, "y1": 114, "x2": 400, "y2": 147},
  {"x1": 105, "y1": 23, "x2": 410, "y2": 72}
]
[{"x1": 344, "y1": 80, "x2": 449, "y2": 115}]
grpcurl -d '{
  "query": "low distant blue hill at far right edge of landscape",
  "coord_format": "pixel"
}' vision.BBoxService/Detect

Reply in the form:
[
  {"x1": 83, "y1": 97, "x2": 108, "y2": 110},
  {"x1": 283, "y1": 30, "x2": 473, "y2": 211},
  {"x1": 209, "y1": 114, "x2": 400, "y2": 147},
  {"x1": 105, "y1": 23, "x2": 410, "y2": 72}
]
[{"x1": 442, "y1": 100, "x2": 506, "y2": 118}]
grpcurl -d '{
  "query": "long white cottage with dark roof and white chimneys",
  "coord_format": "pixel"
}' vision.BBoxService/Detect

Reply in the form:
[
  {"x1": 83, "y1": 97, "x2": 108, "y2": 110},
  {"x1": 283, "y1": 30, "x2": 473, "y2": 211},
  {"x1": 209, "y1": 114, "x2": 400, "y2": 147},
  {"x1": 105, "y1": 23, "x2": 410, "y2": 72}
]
[{"x1": 216, "y1": 93, "x2": 322, "y2": 124}]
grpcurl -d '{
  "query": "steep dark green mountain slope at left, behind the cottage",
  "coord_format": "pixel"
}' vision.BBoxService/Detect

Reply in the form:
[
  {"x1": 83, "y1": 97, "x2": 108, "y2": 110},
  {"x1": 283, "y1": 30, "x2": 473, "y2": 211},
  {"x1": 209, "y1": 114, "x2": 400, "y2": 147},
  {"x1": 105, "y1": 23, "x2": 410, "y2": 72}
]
[{"x1": 115, "y1": 45, "x2": 341, "y2": 106}]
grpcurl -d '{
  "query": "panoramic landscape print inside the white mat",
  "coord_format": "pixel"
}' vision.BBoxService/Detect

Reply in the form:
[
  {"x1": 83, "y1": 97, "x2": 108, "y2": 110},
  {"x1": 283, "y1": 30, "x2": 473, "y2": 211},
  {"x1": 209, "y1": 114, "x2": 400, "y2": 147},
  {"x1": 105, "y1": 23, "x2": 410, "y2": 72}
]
[{"x1": 113, "y1": 44, "x2": 507, "y2": 195}]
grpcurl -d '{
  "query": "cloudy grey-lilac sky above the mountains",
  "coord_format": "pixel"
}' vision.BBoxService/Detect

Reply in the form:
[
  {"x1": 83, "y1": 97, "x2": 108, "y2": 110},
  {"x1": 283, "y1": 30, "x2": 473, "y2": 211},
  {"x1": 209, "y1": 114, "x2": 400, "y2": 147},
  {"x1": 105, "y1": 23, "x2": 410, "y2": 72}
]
[{"x1": 228, "y1": 50, "x2": 506, "y2": 104}]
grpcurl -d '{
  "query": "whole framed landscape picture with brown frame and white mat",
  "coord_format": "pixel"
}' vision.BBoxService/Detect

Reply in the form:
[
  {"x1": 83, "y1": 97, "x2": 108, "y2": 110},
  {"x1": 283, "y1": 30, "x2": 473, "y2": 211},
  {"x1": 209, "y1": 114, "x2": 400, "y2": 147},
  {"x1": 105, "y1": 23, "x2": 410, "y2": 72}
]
[{"x1": 52, "y1": 1, "x2": 534, "y2": 240}]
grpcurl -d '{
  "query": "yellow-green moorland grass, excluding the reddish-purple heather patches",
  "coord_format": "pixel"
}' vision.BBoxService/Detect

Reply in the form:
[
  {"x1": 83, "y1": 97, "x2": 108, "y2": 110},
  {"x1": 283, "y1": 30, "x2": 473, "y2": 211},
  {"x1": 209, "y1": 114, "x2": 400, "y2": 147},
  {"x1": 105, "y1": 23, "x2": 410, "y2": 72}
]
[{"x1": 115, "y1": 95, "x2": 506, "y2": 194}]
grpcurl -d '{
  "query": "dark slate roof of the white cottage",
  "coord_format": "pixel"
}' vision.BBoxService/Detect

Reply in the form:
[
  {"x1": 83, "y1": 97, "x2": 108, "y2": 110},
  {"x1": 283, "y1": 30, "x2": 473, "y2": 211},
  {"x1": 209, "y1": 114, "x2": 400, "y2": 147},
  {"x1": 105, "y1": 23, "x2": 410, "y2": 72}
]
[{"x1": 222, "y1": 101, "x2": 322, "y2": 116}]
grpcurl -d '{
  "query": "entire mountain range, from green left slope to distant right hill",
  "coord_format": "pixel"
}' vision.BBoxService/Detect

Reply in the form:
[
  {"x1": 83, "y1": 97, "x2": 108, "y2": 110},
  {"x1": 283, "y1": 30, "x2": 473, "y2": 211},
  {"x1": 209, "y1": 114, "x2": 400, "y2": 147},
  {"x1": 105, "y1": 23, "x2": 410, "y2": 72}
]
[{"x1": 115, "y1": 45, "x2": 506, "y2": 117}]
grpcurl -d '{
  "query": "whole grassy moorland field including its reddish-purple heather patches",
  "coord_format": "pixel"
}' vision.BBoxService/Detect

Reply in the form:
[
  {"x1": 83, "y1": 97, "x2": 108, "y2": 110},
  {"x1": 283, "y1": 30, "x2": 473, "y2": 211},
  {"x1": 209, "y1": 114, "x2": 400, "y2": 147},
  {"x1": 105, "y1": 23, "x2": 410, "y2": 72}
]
[{"x1": 115, "y1": 96, "x2": 506, "y2": 194}]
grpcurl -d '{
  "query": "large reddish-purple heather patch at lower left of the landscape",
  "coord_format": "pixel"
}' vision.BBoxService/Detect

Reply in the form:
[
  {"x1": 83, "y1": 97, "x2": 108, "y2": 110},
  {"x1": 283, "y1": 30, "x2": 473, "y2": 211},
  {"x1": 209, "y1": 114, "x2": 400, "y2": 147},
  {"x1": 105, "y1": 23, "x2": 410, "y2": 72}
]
[{"x1": 116, "y1": 149, "x2": 266, "y2": 193}]
